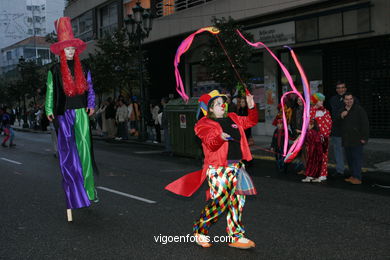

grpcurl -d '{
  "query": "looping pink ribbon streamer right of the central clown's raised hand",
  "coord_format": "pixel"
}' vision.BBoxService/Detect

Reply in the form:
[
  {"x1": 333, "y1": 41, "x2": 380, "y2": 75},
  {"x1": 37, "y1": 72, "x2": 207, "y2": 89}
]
[{"x1": 236, "y1": 30, "x2": 310, "y2": 162}]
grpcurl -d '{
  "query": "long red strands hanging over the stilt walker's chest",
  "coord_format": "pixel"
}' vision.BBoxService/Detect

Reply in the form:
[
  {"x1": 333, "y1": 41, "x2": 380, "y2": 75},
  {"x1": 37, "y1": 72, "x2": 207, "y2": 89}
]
[{"x1": 60, "y1": 50, "x2": 88, "y2": 97}]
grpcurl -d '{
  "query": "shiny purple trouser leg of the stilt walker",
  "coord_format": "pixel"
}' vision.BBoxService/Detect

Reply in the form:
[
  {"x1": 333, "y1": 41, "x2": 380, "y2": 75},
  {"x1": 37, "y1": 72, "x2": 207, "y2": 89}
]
[{"x1": 57, "y1": 109, "x2": 91, "y2": 209}]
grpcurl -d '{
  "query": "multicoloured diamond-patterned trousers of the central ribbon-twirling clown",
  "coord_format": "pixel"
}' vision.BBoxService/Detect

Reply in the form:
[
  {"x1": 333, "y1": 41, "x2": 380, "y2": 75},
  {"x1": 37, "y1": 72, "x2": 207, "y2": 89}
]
[{"x1": 193, "y1": 163, "x2": 245, "y2": 241}]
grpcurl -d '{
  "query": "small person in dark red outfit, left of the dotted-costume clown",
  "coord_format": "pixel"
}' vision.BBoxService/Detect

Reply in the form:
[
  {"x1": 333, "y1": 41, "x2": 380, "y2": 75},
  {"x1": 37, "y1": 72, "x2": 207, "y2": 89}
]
[{"x1": 302, "y1": 119, "x2": 322, "y2": 182}]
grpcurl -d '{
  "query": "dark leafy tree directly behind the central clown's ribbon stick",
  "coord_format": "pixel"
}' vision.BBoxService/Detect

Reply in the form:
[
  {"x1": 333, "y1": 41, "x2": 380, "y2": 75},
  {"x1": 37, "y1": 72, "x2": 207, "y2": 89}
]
[{"x1": 201, "y1": 17, "x2": 253, "y2": 90}]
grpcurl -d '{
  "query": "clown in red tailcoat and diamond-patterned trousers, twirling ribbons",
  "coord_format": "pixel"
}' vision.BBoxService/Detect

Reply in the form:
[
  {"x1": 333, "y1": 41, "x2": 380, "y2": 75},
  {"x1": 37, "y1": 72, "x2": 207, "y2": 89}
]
[{"x1": 166, "y1": 90, "x2": 258, "y2": 249}]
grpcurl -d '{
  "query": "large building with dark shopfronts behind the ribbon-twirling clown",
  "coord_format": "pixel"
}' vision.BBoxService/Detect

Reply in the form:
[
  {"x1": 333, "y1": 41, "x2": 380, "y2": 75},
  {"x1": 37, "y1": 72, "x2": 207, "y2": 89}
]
[{"x1": 65, "y1": 0, "x2": 390, "y2": 138}]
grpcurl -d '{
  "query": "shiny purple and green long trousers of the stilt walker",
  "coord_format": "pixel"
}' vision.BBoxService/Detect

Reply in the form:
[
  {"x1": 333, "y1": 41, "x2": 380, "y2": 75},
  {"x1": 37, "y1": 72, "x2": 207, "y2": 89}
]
[{"x1": 56, "y1": 108, "x2": 96, "y2": 209}]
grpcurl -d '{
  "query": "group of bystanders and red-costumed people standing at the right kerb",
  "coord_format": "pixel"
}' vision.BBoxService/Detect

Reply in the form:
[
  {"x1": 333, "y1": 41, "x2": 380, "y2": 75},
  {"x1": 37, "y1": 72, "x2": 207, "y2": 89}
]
[{"x1": 271, "y1": 81, "x2": 369, "y2": 184}]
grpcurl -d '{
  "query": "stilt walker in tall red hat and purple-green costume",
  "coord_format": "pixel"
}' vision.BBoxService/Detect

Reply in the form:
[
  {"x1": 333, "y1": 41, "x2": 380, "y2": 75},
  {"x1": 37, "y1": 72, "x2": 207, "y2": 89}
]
[{"x1": 45, "y1": 17, "x2": 97, "y2": 221}]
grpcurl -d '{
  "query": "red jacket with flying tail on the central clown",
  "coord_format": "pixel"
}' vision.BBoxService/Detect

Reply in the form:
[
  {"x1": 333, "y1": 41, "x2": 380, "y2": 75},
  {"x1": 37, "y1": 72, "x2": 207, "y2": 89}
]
[{"x1": 165, "y1": 107, "x2": 258, "y2": 197}]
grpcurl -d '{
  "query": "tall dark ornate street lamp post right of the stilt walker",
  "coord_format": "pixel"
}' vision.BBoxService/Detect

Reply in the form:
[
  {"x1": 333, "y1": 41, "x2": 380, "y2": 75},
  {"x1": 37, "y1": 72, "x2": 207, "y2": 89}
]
[{"x1": 125, "y1": 1, "x2": 152, "y2": 141}]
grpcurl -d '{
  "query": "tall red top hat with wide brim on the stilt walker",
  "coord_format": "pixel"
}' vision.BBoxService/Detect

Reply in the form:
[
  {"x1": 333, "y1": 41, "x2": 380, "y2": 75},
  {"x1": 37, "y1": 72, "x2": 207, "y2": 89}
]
[{"x1": 50, "y1": 17, "x2": 87, "y2": 55}]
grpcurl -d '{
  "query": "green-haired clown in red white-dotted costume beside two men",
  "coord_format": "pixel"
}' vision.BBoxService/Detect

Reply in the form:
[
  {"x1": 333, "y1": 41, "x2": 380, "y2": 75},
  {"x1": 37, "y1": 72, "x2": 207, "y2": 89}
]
[{"x1": 310, "y1": 92, "x2": 332, "y2": 182}]
